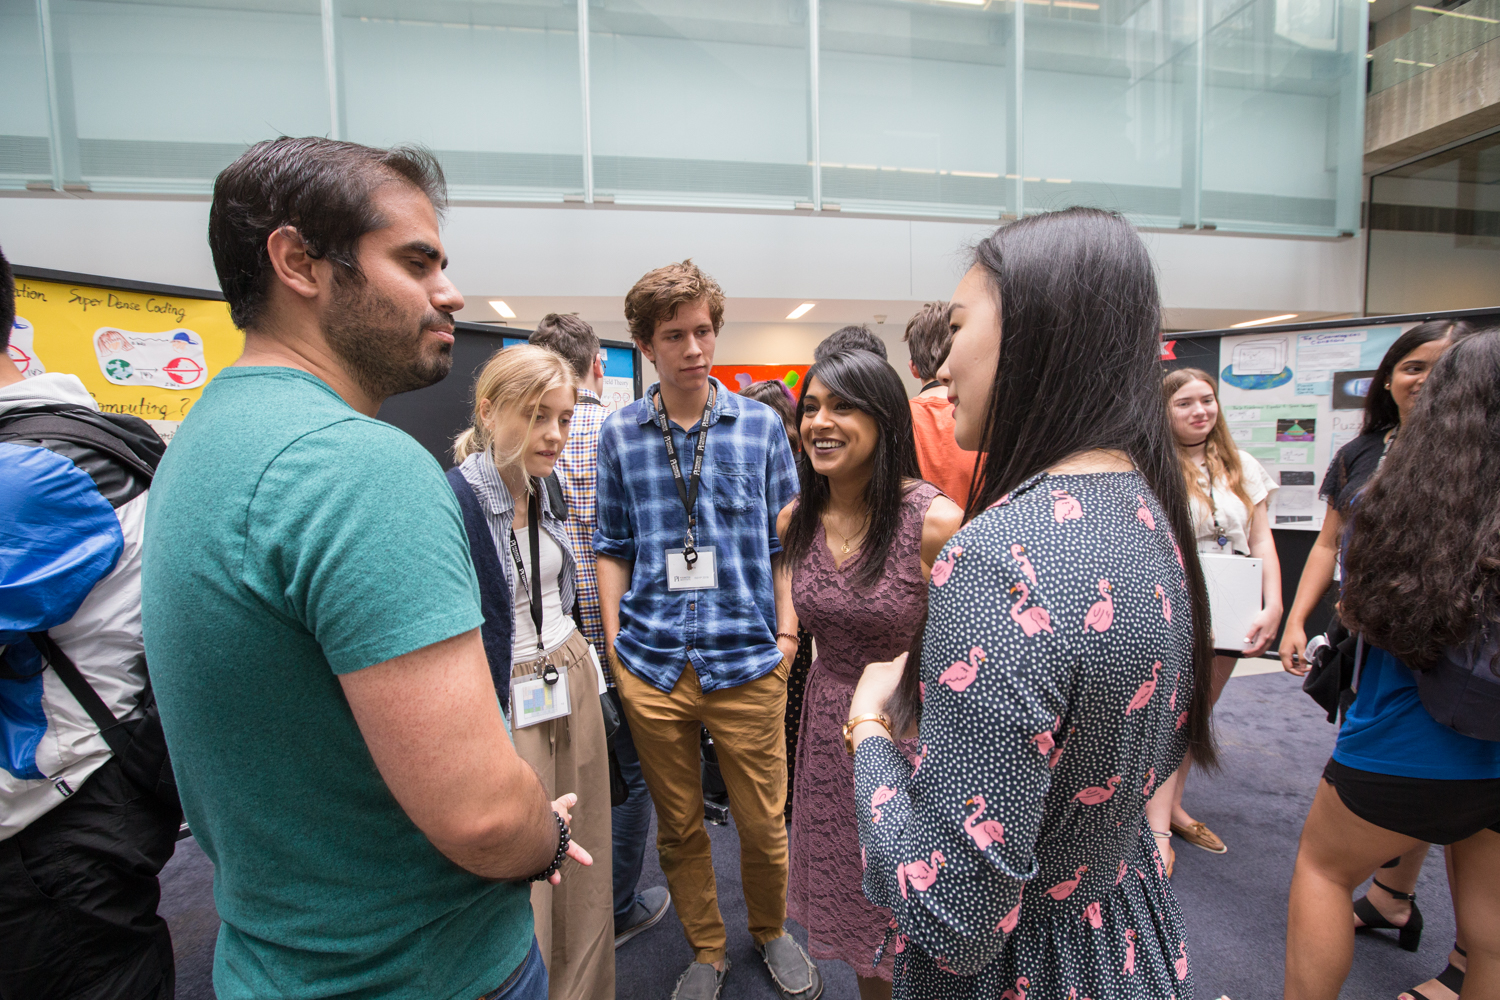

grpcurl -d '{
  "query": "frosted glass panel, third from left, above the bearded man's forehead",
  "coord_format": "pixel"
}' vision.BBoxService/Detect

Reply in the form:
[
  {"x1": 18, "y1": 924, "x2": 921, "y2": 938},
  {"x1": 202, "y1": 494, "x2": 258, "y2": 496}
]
[{"x1": 336, "y1": 0, "x2": 584, "y2": 201}]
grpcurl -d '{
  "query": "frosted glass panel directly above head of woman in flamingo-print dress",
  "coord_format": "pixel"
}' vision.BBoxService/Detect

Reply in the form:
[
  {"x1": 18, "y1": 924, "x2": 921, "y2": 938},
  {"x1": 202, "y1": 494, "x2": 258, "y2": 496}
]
[{"x1": 1022, "y1": 0, "x2": 1196, "y2": 226}]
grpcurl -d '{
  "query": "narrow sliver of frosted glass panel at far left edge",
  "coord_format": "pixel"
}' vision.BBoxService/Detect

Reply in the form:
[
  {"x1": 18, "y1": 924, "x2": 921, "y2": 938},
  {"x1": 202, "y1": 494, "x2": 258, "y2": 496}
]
[{"x1": 0, "y1": 0, "x2": 53, "y2": 189}]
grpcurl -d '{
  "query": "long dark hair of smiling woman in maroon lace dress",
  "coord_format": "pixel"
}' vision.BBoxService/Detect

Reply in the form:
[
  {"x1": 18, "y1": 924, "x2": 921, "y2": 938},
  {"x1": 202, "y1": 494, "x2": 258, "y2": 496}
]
[{"x1": 782, "y1": 351, "x2": 923, "y2": 586}]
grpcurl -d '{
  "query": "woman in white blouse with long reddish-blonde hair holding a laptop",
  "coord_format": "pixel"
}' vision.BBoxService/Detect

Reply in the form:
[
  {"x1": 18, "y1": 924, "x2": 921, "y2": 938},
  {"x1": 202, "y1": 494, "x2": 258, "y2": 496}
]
[{"x1": 1146, "y1": 369, "x2": 1281, "y2": 874}]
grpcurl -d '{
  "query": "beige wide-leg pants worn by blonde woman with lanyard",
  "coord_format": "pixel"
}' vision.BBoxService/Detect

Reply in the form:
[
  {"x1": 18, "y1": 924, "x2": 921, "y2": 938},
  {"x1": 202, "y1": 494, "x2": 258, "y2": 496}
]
[{"x1": 510, "y1": 631, "x2": 615, "y2": 1000}]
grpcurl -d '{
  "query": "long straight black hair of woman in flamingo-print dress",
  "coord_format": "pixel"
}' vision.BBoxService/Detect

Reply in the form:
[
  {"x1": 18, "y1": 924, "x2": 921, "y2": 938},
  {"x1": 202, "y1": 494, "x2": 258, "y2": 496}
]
[{"x1": 887, "y1": 208, "x2": 1218, "y2": 766}]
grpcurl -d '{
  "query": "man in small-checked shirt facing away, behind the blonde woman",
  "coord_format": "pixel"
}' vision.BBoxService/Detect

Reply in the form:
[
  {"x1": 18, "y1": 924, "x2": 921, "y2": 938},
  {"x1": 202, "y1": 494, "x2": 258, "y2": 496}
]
[{"x1": 530, "y1": 312, "x2": 672, "y2": 948}]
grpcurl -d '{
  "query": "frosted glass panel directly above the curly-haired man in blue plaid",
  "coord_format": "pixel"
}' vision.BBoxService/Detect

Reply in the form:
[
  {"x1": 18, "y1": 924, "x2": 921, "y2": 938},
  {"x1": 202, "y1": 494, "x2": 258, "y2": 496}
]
[{"x1": 590, "y1": 0, "x2": 812, "y2": 208}]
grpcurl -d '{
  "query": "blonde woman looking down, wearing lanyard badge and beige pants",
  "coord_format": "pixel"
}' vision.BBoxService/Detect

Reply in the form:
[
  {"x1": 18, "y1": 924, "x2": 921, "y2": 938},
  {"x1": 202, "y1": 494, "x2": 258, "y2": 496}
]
[{"x1": 449, "y1": 345, "x2": 615, "y2": 1000}]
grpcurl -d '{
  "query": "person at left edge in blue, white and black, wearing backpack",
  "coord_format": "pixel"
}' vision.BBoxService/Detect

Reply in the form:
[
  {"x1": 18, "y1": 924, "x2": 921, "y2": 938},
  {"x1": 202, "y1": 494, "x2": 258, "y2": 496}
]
[{"x1": 0, "y1": 244, "x2": 182, "y2": 1000}]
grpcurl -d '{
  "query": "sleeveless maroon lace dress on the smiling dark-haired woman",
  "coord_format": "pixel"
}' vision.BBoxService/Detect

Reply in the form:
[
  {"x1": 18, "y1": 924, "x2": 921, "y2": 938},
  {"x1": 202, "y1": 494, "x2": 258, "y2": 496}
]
[{"x1": 786, "y1": 483, "x2": 939, "y2": 981}]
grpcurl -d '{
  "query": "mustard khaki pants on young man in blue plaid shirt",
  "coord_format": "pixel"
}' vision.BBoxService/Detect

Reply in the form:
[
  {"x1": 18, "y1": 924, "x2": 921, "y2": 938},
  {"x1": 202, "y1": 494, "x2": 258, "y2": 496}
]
[{"x1": 615, "y1": 660, "x2": 788, "y2": 963}]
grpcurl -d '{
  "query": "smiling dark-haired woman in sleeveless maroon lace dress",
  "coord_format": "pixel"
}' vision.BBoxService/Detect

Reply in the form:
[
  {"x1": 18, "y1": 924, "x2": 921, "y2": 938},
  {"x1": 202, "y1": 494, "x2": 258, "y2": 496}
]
[{"x1": 777, "y1": 351, "x2": 963, "y2": 999}]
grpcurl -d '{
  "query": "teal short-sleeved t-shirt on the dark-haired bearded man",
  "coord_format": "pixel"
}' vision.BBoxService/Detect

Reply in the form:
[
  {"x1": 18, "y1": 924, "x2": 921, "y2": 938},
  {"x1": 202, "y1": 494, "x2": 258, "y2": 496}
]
[{"x1": 141, "y1": 367, "x2": 533, "y2": 1000}]
